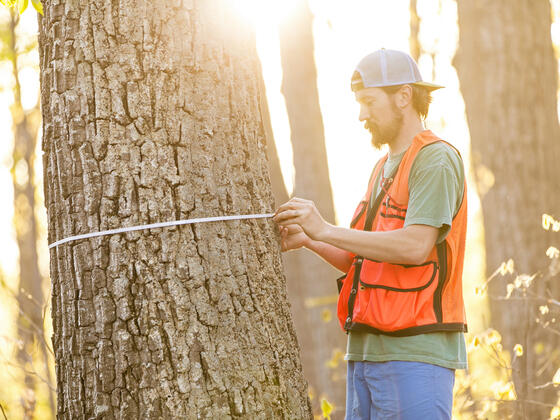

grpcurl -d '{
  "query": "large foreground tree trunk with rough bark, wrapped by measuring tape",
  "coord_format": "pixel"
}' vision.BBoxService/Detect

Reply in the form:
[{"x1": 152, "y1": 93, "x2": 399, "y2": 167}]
[{"x1": 39, "y1": 0, "x2": 311, "y2": 419}]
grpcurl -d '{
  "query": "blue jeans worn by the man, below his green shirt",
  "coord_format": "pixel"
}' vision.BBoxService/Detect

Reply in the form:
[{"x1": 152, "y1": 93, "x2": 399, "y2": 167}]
[{"x1": 346, "y1": 361, "x2": 455, "y2": 420}]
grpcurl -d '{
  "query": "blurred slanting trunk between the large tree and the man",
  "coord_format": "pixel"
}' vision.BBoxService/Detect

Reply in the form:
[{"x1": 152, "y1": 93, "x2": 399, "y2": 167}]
[{"x1": 280, "y1": 1, "x2": 345, "y2": 411}]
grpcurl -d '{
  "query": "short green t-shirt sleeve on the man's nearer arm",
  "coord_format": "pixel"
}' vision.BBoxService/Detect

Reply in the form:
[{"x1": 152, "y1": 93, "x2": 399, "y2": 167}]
[{"x1": 404, "y1": 142, "x2": 465, "y2": 243}]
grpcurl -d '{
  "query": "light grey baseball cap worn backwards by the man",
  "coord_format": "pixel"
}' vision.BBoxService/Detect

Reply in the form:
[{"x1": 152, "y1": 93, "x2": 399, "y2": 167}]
[{"x1": 352, "y1": 48, "x2": 444, "y2": 92}]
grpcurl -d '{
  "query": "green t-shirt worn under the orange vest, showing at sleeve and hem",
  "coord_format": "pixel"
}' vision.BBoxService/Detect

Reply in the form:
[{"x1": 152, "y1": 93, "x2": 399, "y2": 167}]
[{"x1": 345, "y1": 142, "x2": 467, "y2": 369}]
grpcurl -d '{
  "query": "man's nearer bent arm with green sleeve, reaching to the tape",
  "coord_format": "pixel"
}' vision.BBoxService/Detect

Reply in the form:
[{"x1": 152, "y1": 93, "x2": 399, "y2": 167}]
[{"x1": 274, "y1": 143, "x2": 464, "y2": 271}]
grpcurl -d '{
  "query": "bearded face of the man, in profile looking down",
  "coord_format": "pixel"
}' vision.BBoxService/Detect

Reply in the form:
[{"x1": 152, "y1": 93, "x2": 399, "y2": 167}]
[{"x1": 356, "y1": 88, "x2": 403, "y2": 149}]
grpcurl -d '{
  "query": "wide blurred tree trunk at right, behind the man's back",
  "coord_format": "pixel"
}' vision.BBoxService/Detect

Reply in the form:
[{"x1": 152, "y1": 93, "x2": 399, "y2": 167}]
[{"x1": 455, "y1": 0, "x2": 560, "y2": 418}]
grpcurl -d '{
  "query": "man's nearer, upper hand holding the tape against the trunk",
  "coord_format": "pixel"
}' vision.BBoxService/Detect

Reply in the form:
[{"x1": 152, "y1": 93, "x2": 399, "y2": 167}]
[{"x1": 272, "y1": 197, "x2": 331, "y2": 241}]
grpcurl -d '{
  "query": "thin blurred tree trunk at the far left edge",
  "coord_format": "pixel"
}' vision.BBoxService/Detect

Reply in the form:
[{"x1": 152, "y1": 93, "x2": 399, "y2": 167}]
[{"x1": 8, "y1": 8, "x2": 55, "y2": 419}]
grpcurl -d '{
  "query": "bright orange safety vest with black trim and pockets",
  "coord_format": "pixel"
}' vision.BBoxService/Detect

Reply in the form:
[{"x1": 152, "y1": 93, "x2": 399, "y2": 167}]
[{"x1": 338, "y1": 130, "x2": 467, "y2": 336}]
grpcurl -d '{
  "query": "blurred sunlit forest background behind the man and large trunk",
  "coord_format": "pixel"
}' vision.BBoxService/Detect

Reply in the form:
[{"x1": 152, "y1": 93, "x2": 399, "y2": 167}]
[{"x1": 0, "y1": 0, "x2": 560, "y2": 419}]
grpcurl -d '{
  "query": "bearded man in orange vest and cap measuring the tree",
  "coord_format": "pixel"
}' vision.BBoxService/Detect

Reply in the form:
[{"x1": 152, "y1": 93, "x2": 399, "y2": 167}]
[{"x1": 274, "y1": 49, "x2": 467, "y2": 420}]
